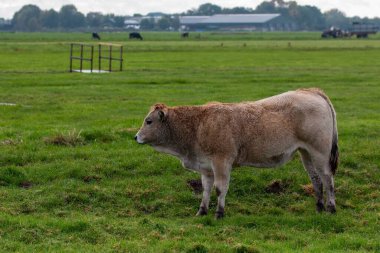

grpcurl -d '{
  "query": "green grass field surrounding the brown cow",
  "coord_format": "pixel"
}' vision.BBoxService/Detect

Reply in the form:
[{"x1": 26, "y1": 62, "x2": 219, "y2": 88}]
[{"x1": 0, "y1": 33, "x2": 380, "y2": 252}]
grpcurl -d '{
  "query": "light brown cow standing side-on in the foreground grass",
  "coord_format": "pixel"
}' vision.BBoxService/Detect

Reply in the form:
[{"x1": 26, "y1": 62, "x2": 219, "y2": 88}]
[{"x1": 135, "y1": 88, "x2": 339, "y2": 218}]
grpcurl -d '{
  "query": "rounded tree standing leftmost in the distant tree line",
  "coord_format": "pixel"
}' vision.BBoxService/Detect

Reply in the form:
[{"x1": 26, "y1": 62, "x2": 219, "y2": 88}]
[{"x1": 12, "y1": 4, "x2": 42, "y2": 32}]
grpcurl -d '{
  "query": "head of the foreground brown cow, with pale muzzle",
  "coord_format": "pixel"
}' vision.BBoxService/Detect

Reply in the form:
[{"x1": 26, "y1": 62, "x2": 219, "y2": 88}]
[{"x1": 135, "y1": 104, "x2": 168, "y2": 146}]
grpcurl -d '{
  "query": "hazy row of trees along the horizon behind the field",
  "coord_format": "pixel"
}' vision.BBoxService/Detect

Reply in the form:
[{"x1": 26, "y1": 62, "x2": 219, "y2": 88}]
[{"x1": 0, "y1": 0, "x2": 380, "y2": 31}]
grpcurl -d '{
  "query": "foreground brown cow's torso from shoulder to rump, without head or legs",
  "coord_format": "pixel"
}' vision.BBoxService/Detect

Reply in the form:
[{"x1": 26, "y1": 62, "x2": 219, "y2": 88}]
[{"x1": 196, "y1": 90, "x2": 332, "y2": 167}]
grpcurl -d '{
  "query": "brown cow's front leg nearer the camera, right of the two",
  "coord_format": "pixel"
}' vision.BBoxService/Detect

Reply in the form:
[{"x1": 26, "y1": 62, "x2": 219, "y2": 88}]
[{"x1": 212, "y1": 159, "x2": 231, "y2": 219}]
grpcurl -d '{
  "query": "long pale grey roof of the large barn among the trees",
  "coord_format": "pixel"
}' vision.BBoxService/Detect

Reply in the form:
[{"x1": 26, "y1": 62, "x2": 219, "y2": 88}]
[{"x1": 179, "y1": 13, "x2": 280, "y2": 25}]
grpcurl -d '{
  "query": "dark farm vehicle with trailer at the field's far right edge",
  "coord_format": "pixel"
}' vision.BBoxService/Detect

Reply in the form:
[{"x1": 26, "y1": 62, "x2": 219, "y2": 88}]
[{"x1": 321, "y1": 22, "x2": 379, "y2": 38}]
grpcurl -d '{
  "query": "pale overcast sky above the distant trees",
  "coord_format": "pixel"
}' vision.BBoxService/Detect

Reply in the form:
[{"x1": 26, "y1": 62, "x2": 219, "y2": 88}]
[{"x1": 0, "y1": 0, "x2": 380, "y2": 19}]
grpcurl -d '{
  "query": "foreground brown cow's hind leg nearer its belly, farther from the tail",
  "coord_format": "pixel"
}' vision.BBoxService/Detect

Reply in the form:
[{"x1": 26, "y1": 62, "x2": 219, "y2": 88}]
[{"x1": 300, "y1": 150, "x2": 325, "y2": 212}]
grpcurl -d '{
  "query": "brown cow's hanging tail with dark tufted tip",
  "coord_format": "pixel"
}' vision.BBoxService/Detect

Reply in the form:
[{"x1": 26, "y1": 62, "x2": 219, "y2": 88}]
[{"x1": 300, "y1": 88, "x2": 339, "y2": 175}]
